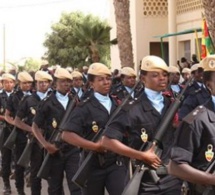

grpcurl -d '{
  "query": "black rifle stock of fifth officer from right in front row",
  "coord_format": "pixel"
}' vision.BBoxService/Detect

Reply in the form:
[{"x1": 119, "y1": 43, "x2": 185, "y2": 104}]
[{"x1": 17, "y1": 136, "x2": 34, "y2": 167}]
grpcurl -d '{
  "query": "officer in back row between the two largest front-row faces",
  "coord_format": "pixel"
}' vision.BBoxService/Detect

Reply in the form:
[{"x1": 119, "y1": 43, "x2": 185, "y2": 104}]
[{"x1": 111, "y1": 67, "x2": 141, "y2": 101}]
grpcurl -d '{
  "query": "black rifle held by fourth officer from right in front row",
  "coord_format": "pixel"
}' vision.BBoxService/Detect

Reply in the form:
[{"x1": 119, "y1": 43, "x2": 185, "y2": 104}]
[{"x1": 37, "y1": 92, "x2": 78, "y2": 179}]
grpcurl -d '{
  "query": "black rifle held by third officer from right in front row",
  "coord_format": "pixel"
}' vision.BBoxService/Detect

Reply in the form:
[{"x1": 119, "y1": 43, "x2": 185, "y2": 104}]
[{"x1": 72, "y1": 81, "x2": 139, "y2": 188}]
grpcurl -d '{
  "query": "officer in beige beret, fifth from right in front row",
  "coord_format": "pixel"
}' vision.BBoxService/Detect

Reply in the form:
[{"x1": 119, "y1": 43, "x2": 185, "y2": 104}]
[{"x1": 15, "y1": 70, "x2": 53, "y2": 195}]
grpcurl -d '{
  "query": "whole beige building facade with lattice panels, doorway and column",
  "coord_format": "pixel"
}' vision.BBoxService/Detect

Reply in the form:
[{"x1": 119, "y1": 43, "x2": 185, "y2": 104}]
[{"x1": 110, "y1": 0, "x2": 203, "y2": 69}]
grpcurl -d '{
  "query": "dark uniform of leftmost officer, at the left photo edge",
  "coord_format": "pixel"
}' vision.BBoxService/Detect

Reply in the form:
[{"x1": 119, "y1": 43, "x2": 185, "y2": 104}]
[{"x1": 0, "y1": 90, "x2": 13, "y2": 191}]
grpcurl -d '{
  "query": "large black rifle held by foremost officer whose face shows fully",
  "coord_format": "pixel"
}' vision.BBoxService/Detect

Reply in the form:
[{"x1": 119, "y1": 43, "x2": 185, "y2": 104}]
[{"x1": 122, "y1": 78, "x2": 193, "y2": 195}]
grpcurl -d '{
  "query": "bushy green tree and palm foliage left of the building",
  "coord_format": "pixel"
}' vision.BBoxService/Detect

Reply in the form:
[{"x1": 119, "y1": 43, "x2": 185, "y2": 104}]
[{"x1": 44, "y1": 12, "x2": 111, "y2": 68}]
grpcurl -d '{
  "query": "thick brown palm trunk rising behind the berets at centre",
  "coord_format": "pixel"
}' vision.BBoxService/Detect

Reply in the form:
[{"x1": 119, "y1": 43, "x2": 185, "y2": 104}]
[{"x1": 113, "y1": 0, "x2": 134, "y2": 68}]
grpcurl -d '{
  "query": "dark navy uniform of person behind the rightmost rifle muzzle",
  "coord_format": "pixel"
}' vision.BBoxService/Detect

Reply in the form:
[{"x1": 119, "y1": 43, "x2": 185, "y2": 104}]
[{"x1": 179, "y1": 86, "x2": 210, "y2": 120}]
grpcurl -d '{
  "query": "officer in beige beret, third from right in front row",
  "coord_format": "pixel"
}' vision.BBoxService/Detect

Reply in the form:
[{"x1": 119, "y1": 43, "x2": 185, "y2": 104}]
[{"x1": 62, "y1": 63, "x2": 130, "y2": 195}]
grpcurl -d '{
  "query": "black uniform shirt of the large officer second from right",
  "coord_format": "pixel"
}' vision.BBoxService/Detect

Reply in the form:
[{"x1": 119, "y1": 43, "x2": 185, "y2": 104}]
[{"x1": 104, "y1": 93, "x2": 174, "y2": 163}]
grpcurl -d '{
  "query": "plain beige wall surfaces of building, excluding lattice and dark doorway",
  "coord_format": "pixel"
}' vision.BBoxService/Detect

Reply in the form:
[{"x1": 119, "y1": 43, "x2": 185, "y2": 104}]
[{"x1": 110, "y1": 0, "x2": 202, "y2": 69}]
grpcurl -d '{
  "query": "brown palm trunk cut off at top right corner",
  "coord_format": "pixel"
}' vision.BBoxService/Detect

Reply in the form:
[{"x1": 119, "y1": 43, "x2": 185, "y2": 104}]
[{"x1": 202, "y1": 0, "x2": 215, "y2": 46}]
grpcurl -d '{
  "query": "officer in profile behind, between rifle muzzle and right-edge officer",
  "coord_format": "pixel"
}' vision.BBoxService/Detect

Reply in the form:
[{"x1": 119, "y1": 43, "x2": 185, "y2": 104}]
[{"x1": 179, "y1": 64, "x2": 210, "y2": 121}]
